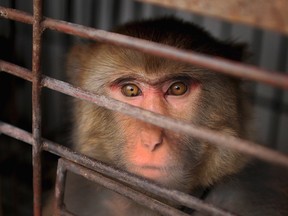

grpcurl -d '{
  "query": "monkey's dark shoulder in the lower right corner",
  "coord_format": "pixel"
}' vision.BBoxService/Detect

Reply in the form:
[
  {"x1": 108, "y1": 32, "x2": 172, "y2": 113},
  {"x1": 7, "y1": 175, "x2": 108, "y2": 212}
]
[{"x1": 195, "y1": 163, "x2": 288, "y2": 216}]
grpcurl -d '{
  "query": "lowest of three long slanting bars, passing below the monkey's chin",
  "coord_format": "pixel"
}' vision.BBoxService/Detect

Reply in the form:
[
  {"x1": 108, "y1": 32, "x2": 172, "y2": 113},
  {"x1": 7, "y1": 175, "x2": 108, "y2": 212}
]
[{"x1": 0, "y1": 121, "x2": 235, "y2": 216}]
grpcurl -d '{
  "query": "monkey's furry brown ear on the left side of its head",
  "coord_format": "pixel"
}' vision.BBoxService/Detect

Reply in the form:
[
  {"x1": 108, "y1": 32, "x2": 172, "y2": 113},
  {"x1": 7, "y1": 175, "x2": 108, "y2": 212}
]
[{"x1": 66, "y1": 44, "x2": 91, "y2": 85}]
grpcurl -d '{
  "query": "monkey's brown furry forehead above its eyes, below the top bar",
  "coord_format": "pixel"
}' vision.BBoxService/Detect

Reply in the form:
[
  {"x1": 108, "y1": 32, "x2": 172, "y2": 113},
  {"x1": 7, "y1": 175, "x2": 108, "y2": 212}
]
[{"x1": 86, "y1": 45, "x2": 207, "y2": 79}]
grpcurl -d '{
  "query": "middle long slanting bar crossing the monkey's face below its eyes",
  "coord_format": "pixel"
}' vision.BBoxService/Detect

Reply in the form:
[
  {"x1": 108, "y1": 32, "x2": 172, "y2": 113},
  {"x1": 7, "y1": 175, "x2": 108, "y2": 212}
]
[{"x1": 0, "y1": 61, "x2": 288, "y2": 167}]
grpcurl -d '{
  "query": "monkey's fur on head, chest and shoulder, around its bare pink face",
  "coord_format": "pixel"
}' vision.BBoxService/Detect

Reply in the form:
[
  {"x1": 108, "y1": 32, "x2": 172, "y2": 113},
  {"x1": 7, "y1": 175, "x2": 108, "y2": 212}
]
[{"x1": 44, "y1": 18, "x2": 288, "y2": 216}]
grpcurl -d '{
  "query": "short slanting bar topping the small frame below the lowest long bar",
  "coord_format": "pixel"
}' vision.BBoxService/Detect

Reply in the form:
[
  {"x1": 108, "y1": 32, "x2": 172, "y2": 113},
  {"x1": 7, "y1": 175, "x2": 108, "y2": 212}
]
[{"x1": 56, "y1": 159, "x2": 188, "y2": 216}]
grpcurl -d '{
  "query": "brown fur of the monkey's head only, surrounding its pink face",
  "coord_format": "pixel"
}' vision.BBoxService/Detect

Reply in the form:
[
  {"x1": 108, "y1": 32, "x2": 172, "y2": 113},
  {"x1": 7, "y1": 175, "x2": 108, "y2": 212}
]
[{"x1": 63, "y1": 18, "x2": 252, "y2": 215}]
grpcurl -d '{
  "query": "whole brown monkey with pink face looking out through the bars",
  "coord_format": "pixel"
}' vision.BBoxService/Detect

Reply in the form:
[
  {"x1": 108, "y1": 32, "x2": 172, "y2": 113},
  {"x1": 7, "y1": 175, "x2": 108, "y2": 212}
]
[{"x1": 42, "y1": 17, "x2": 288, "y2": 216}]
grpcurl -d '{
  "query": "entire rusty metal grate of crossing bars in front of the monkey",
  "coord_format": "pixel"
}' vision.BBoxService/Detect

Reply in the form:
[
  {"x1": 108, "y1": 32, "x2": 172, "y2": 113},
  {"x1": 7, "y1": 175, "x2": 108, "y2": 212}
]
[{"x1": 0, "y1": 0, "x2": 288, "y2": 216}]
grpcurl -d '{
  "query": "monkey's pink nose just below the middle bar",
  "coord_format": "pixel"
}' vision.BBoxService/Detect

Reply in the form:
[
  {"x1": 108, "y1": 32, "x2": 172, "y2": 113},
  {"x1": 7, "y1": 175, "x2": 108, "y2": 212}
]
[{"x1": 141, "y1": 125, "x2": 163, "y2": 152}]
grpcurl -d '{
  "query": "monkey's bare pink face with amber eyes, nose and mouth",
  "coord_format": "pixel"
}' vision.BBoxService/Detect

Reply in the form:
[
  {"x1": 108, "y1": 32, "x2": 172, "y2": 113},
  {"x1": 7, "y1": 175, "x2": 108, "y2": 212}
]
[{"x1": 108, "y1": 73, "x2": 201, "y2": 189}]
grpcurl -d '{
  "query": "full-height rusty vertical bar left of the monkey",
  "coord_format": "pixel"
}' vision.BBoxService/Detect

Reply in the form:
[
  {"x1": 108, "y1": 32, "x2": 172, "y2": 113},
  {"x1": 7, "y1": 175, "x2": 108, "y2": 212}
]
[{"x1": 32, "y1": 0, "x2": 42, "y2": 216}]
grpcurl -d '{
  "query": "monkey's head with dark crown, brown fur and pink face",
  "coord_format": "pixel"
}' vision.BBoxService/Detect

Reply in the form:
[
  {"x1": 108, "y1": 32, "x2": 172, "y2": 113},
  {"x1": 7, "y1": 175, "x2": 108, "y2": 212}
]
[{"x1": 68, "y1": 18, "x2": 250, "y2": 191}]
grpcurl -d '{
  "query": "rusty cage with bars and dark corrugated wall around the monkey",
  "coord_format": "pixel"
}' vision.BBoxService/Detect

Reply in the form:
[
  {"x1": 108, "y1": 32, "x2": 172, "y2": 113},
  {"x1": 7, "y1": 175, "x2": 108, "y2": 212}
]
[{"x1": 0, "y1": 0, "x2": 288, "y2": 215}]
